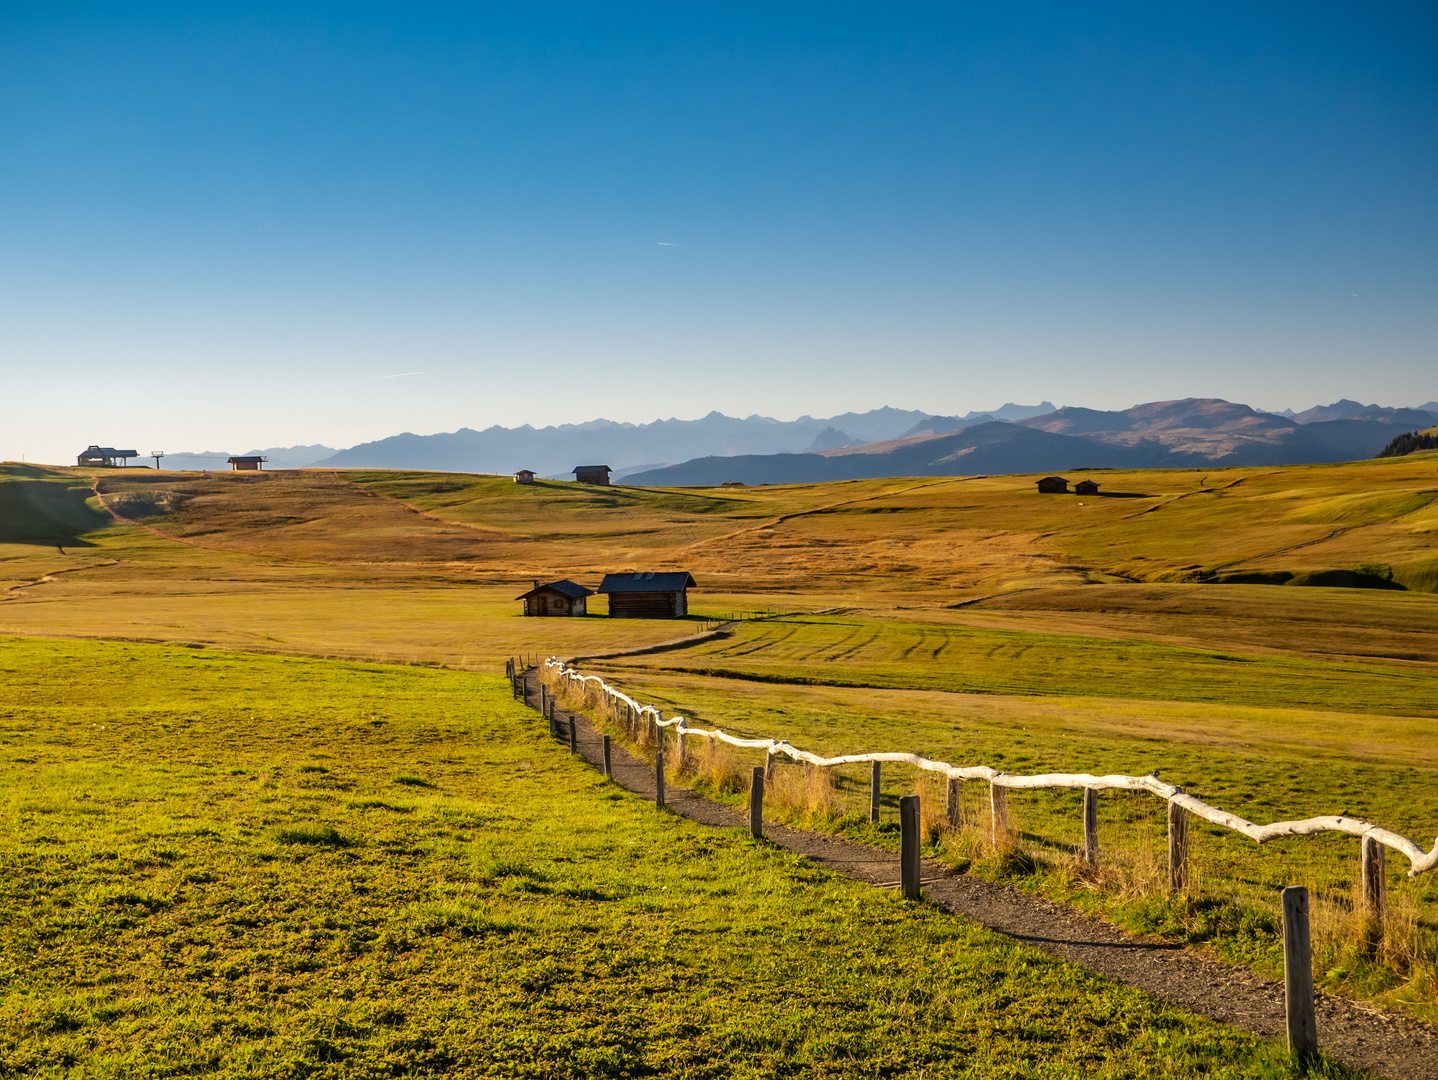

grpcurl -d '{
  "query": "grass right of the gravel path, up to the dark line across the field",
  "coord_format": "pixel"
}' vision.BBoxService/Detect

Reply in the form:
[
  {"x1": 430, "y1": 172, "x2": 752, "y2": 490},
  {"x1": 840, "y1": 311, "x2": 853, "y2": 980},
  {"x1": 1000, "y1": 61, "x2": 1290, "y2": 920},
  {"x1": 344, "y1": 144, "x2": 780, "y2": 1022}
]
[{"x1": 560, "y1": 654, "x2": 1438, "y2": 1020}]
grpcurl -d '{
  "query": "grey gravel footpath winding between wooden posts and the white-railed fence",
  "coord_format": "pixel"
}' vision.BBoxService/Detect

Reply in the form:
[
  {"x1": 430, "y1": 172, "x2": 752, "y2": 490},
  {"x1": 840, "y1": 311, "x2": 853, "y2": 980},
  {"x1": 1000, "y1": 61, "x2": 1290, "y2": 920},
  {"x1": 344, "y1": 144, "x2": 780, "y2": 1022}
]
[{"x1": 525, "y1": 672, "x2": 1438, "y2": 1080}]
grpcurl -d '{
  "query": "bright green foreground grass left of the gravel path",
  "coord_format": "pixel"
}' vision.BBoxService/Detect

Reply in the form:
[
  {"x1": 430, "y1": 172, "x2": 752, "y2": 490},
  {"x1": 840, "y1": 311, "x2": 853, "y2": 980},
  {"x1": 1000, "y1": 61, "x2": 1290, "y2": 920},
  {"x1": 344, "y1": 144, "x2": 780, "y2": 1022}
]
[{"x1": 0, "y1": 639, "x2": 1342, "y2": 1077}]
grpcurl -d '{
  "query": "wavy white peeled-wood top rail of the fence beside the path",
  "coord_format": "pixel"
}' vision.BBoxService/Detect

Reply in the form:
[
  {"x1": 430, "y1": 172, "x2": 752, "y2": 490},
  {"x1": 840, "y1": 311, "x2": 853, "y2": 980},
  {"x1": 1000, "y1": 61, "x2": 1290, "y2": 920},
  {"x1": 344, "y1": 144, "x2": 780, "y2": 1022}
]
[{"x1": 542, "y1": 657, "x2": 1438, "y2": 877}]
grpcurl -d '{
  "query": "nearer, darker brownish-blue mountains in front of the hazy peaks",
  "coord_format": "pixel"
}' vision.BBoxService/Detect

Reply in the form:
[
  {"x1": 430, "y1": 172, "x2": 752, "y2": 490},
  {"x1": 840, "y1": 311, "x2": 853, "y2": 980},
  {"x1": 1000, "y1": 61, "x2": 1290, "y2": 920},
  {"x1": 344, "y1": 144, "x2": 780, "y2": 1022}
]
[{"x1": 626, "y1": 398, "x2": 1438, "y2": 486}]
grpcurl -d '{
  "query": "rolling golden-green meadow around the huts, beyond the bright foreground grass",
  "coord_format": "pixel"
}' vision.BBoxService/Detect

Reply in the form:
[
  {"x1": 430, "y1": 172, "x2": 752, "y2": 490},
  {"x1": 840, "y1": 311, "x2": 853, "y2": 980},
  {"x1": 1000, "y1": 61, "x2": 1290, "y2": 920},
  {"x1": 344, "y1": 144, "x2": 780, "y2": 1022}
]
[{"x1": 0, "y1": 453, "x2": 1438, "y2": 1046}]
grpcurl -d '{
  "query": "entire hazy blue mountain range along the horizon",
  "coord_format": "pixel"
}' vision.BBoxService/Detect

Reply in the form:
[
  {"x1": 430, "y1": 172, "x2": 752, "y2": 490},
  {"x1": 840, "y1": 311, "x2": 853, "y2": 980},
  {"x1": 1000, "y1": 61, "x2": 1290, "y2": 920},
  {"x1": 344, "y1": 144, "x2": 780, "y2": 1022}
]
[{"x1": 151, "y1": 398, "x2": 1438, "y2": 485}]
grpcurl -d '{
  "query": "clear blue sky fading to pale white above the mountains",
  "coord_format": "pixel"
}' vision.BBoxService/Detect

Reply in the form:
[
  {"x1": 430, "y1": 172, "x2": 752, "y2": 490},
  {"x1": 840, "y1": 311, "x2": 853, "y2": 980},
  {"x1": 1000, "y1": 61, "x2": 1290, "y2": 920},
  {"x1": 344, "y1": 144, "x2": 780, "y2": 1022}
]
[{"x1": 0, "y1": 0, "x2": 1438, "y2": 460}]
